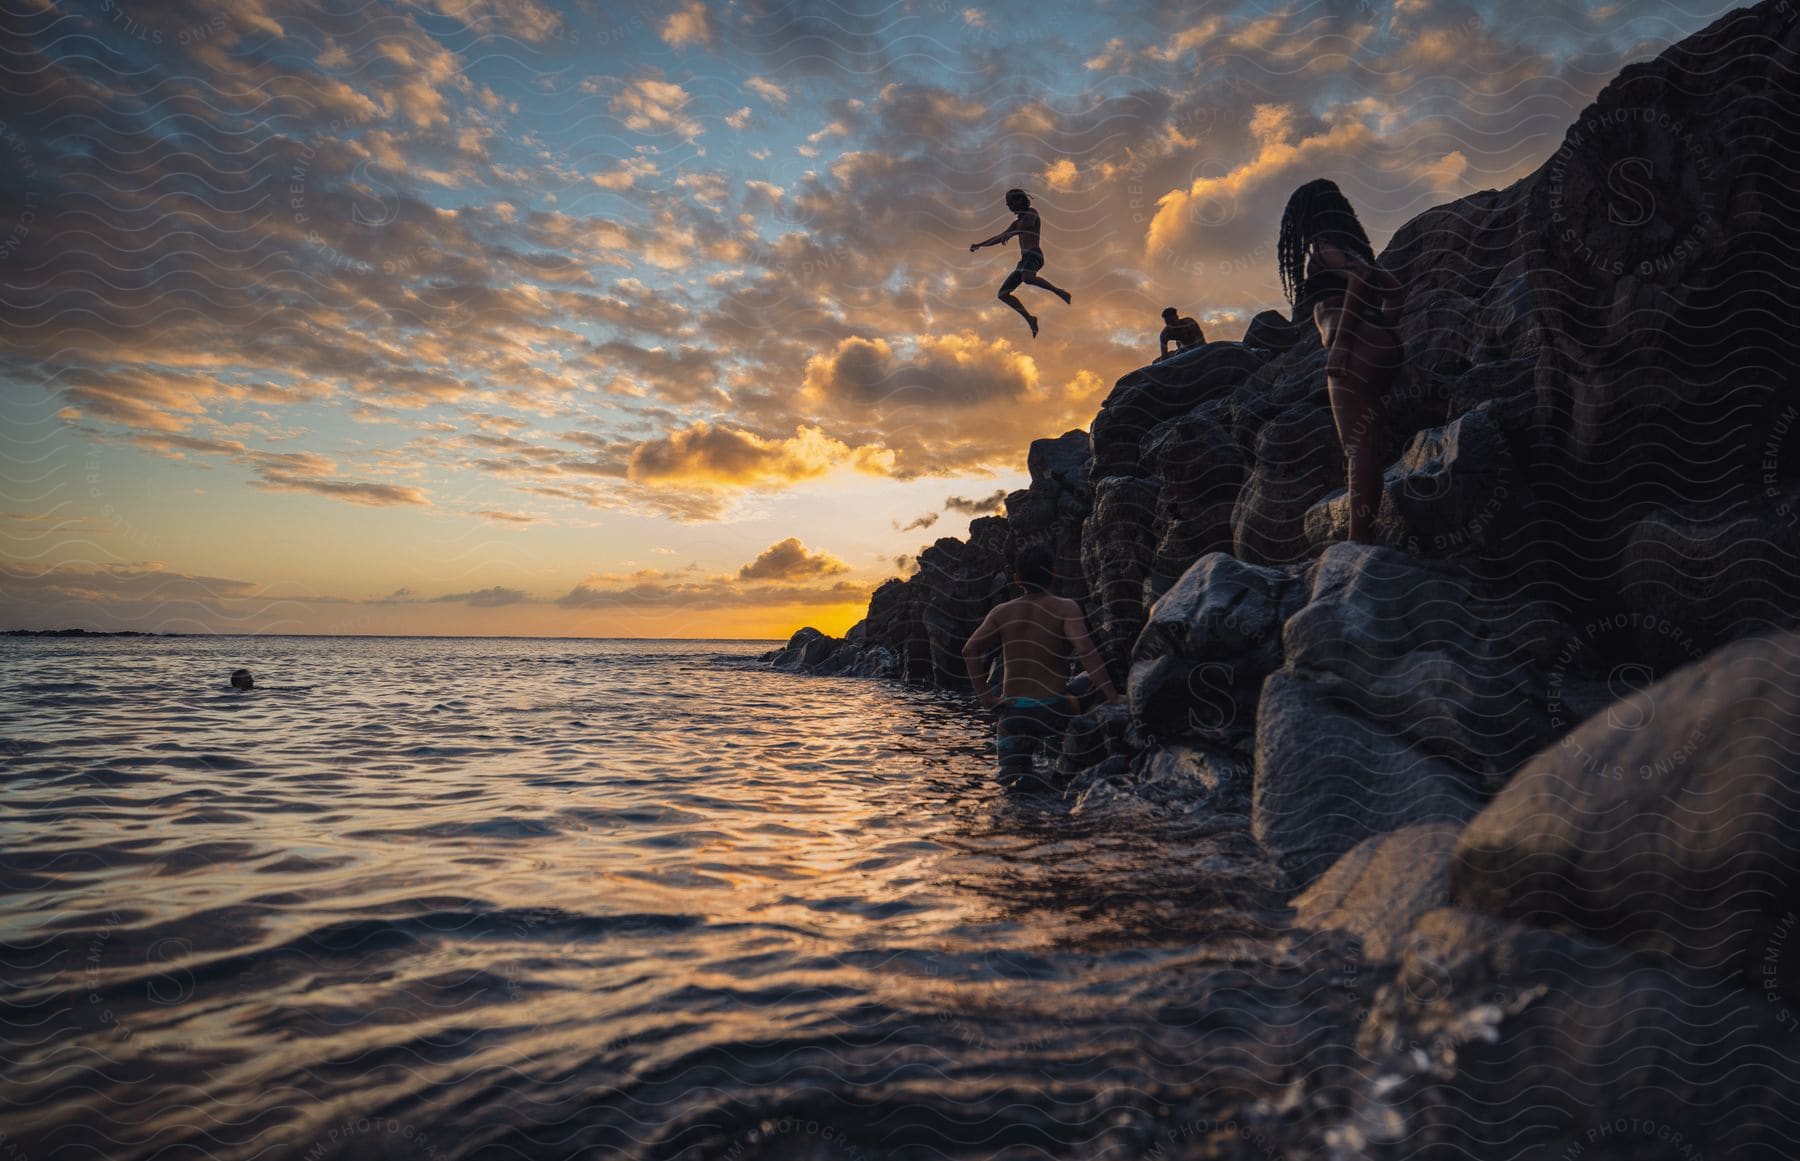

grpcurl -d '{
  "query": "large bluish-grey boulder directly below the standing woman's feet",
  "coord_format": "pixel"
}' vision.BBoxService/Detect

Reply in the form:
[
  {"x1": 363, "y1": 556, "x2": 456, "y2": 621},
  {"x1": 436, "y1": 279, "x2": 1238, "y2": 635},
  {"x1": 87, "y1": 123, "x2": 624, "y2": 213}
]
[{"x1": 1255, "y1": 544, "x2": 1559, "y2": 886}]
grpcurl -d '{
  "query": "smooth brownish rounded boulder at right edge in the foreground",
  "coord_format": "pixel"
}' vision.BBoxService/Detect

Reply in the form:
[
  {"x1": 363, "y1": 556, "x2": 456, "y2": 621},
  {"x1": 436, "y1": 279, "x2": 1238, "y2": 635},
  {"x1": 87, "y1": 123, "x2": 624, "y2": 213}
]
[{"x1": 1451, "y1": 634, "x2": 1800, "y2": 1001}]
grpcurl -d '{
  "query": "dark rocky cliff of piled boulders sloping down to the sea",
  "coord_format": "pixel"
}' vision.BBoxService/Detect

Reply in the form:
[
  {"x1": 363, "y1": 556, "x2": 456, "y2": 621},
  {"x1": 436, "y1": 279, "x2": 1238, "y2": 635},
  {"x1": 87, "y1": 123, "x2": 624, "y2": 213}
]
[{"x1": 776, "y1": 0, "x2": 1800, "y2": 1157}]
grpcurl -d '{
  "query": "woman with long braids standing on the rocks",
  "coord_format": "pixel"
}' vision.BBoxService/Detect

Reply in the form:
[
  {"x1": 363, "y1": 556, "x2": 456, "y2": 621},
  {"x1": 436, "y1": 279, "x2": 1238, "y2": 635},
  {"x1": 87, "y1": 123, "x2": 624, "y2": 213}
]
[{"x1": 1276, "y1": 178, "x2": 1402, "y2": 544}]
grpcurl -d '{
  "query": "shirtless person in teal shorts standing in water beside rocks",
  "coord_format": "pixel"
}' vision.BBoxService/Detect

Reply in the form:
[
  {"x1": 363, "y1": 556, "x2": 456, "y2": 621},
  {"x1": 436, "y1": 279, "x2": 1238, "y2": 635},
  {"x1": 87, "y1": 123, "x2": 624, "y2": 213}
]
[{"x1": 963, "y1": 547, "x2": 1120, "y2": 785}]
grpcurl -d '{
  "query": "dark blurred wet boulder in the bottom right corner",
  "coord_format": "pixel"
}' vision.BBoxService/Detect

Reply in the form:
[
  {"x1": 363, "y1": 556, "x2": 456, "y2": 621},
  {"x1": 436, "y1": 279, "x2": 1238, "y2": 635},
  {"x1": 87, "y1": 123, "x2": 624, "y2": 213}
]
[{"x1": 1353, "y1": 907, "x2": 1800, "y2": 1161}]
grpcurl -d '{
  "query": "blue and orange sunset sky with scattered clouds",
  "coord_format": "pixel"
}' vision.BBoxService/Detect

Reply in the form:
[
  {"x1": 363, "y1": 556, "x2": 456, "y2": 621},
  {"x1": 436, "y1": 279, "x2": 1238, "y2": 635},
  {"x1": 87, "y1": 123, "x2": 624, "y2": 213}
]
[{"x1": 0, "y1": 0, "x2": 1726, "y2": 637}]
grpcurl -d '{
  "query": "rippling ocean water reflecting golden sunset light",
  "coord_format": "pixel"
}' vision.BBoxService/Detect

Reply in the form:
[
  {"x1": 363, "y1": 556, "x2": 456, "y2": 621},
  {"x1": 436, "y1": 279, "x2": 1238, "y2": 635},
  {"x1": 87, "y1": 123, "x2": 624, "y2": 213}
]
[{"x1": 0, "y1": 637, "x2": 1368, "y2": 1161}]
